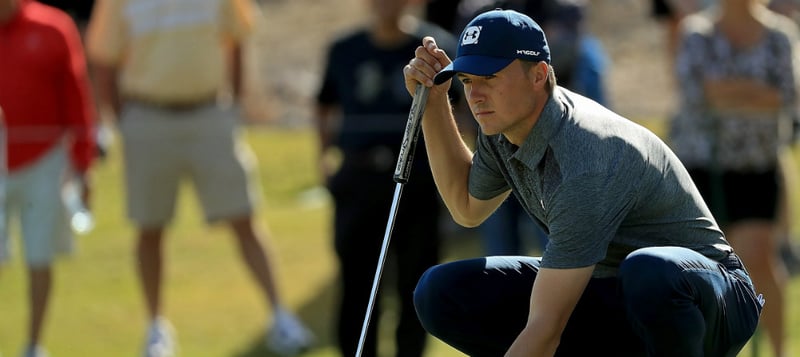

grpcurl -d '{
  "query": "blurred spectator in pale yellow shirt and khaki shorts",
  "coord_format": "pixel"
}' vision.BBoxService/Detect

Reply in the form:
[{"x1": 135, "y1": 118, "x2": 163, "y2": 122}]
[{"x1": 87, "y1": 0, "x2": 314, "y2": 357}]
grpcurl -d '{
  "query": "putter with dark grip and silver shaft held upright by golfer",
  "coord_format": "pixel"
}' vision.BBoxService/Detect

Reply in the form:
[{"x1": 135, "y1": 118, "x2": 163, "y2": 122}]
[{"x1": 356, "y1": 84, "x2": 430, "y2": 357}]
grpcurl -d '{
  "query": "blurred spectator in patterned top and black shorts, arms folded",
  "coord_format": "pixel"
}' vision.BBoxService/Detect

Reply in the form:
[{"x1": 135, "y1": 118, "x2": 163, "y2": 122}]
[{"x1": 670, "y1": 0, "x2": 798, "y2": 357}]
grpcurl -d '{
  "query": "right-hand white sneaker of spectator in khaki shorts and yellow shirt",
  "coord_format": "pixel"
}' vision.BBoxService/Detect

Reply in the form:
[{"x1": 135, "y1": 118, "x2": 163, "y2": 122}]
[{"x1": 267, "y1": 309, "x2": 315, "y2": 356}]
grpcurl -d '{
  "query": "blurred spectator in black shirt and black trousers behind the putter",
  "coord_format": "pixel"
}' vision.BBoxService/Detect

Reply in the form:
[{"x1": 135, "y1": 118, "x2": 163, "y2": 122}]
[{"x1": 317, "y1": 0, "x2": 455, "y2": 357}]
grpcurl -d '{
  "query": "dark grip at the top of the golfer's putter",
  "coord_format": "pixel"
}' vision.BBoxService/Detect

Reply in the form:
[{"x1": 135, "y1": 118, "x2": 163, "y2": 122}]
[{"x1": 394, "y1": 83, "x2": 430, "y2": 184}]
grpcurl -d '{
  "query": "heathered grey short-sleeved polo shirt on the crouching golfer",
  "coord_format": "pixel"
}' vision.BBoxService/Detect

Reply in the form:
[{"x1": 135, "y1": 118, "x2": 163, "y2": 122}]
[{"x1": 469, "y1": 87, "x2": 732, "y2": 277}]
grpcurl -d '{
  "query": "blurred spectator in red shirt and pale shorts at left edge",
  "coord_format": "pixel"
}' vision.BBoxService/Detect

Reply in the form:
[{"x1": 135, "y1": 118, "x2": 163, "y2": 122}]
[{"x1": 0, "y1": 0, "x2": 96, "y2": 357}]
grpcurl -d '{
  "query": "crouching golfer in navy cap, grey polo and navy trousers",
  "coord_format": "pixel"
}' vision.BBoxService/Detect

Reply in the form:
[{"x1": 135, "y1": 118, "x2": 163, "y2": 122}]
[{"x1": 404, "y1": 10, "x2": 762, "y2": 357}]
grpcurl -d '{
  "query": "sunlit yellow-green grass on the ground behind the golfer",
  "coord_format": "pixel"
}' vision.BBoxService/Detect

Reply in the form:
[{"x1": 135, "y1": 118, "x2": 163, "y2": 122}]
[{"x1": 0, "y1": 127, "x2": 800, "y2": 357}]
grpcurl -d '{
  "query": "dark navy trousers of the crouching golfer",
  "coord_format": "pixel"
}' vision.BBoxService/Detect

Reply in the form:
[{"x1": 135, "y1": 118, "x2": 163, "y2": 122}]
[{"x1": 414, "y1": 247, "x2": 762, "y2": 357}]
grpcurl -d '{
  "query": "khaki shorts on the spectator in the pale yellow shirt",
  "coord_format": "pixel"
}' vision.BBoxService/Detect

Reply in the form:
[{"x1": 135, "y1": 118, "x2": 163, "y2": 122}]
[{"x1": 120, "y1": 103, "x2": 260, "y2": 228}]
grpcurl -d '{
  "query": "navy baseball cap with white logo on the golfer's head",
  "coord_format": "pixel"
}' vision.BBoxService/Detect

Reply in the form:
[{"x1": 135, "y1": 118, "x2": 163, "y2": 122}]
[{"x1": 433, "y1": 9, "x2": 550, "y2": 84}]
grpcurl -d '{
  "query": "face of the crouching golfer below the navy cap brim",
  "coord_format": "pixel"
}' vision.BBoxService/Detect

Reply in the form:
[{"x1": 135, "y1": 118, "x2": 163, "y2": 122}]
[{"x1": 458, "y1": 60, "x2": 539, "y2": 142}]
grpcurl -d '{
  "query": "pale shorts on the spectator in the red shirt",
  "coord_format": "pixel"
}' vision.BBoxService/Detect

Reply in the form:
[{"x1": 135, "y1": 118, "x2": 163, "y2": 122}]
[{"x1": 0, "y1": 144, "x2": 74, "y2": 267}]
